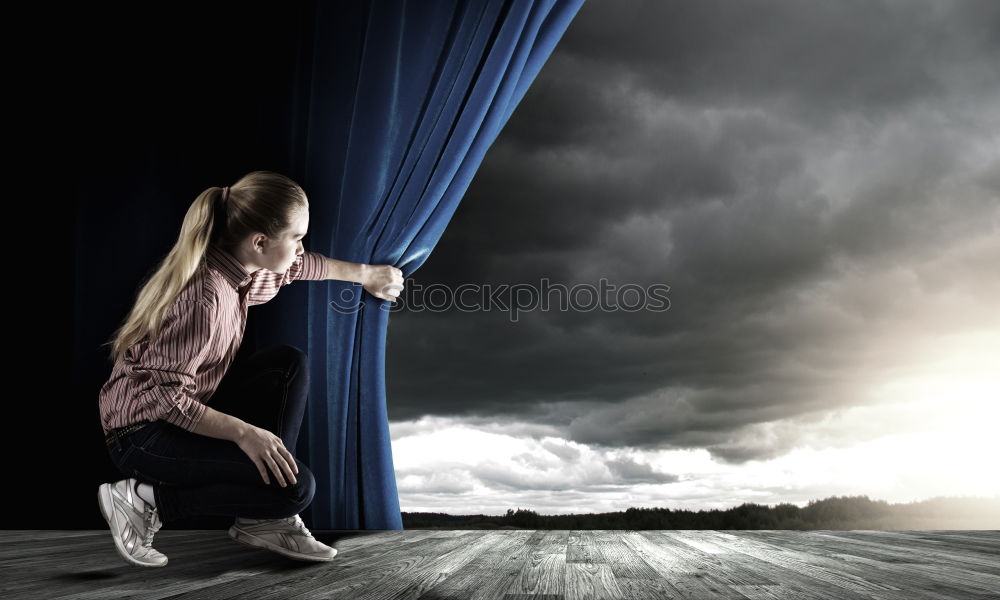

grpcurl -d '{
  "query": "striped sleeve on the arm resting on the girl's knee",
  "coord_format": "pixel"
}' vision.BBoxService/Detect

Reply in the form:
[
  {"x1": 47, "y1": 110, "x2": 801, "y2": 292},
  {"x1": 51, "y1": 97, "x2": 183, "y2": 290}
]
[{"x1": 132, "y1": 300, "x2": 216, "y2": 431}]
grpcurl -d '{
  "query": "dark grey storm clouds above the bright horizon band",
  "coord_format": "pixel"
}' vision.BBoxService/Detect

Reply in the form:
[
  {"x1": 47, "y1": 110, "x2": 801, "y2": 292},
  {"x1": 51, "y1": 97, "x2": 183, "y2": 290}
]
[{"x1": 387, "y1": 0, "x2": 1000, "y2": 464}]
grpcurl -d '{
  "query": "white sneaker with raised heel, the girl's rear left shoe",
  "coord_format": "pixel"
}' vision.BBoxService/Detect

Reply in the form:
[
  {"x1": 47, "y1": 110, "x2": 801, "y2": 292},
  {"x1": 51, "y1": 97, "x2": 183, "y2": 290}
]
[{"x1": 97, "y1": 477, "x2": 167, "y2": 567}]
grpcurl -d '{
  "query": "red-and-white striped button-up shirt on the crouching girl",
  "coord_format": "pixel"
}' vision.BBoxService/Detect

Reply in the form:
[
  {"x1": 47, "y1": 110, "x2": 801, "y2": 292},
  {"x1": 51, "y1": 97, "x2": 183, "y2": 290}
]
[{"x1": 99, "y1": 245, "x2": 326, "y2": 434}]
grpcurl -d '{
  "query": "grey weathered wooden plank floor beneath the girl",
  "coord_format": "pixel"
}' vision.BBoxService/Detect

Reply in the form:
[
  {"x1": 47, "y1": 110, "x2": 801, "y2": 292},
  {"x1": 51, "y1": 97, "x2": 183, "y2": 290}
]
[{"x1": 0, "y1": 530, "x2": 1000, "y2": 600}]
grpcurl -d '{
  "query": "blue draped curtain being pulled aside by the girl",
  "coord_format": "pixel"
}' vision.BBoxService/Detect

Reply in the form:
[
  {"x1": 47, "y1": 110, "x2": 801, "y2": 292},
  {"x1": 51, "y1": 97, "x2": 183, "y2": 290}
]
[{"x1": 272, "y1": 0, "x2": 583, "y2": 529}]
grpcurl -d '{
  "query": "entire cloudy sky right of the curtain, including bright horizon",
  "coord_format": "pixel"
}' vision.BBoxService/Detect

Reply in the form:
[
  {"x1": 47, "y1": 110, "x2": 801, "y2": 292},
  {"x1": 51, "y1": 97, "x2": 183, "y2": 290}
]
[{"x1": 378, "y1": 0, "x2": 1000, "y2": 514}]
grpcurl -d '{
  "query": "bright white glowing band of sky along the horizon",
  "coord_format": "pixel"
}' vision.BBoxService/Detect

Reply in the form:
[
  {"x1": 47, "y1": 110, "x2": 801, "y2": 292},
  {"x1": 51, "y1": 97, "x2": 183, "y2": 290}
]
[{"x1": 393, "y1": 333, "x2": 1000, "y2": 514}]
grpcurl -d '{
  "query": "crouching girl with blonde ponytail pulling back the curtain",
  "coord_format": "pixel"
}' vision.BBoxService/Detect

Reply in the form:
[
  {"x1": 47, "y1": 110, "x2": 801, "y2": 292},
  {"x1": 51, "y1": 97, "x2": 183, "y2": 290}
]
[{"x1": 98, "y1": 171, "x2": 403, "y2": 567}]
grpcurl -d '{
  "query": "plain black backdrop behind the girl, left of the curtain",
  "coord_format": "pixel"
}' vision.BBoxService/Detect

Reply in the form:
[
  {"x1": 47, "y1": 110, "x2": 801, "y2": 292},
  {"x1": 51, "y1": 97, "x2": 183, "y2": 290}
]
[{"x1": 12, "y1": 2, "x2": 328, "y2": 529}]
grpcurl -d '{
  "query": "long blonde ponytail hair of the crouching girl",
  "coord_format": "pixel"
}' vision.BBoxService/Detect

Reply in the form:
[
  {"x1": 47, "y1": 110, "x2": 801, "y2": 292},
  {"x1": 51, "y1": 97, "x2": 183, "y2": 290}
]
[{"x1": 101, "y1": 171, "x2": 309, "y2": 363}]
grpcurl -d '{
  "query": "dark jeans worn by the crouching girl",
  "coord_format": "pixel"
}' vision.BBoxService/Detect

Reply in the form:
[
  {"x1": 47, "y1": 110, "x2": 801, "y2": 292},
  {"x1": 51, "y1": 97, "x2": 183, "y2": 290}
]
[{"x1": 108, "y1": 344, "x2": 316, "y2": 523}]
